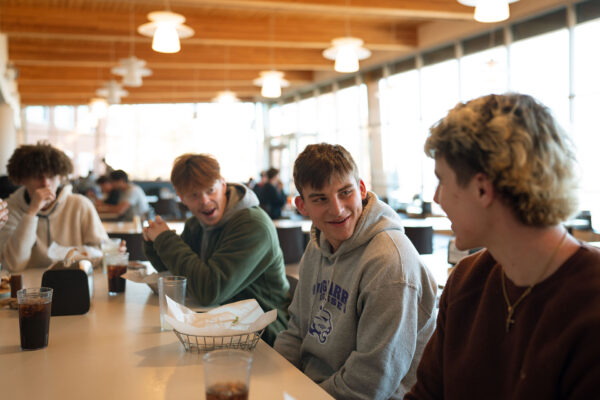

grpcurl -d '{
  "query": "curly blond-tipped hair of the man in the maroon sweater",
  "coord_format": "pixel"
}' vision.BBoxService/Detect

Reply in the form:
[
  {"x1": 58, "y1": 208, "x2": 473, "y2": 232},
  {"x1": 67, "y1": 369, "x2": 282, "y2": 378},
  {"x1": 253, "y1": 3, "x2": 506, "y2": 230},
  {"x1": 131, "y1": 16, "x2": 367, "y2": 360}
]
[{"x1": 425, "y1": 93, "x2": 577, "y2": 226}]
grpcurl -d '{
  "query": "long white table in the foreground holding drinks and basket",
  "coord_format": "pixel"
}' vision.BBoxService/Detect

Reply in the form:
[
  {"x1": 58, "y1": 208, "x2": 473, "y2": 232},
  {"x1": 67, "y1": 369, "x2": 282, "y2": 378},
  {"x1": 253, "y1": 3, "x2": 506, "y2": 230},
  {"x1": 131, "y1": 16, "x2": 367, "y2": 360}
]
[{"x1": 0, "y1": 270, "x2": 331, "y2": 400}]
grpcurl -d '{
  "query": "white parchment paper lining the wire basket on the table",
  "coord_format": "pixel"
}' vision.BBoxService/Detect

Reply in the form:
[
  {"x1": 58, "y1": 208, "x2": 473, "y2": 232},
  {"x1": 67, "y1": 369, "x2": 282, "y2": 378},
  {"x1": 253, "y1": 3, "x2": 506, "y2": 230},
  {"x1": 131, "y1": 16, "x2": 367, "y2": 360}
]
[{"x1": 165, "y1": 296, "x2": 277, "y2": 336}]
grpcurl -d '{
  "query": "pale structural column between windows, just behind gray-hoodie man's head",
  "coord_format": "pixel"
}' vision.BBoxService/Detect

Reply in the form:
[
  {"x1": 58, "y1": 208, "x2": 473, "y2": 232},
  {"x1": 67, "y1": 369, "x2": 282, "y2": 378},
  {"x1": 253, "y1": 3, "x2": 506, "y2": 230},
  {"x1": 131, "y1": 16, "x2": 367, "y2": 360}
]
[{"x1": 367, "y1": 80, "x2": 387, "y2": 197}]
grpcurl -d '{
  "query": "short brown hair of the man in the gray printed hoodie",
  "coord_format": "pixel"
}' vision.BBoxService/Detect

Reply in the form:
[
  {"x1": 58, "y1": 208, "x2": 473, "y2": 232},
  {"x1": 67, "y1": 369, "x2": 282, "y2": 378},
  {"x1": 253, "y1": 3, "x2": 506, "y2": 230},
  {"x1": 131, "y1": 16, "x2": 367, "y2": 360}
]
[{"x1": 294, "y1": 143, "x2": 360, "y2": 196}]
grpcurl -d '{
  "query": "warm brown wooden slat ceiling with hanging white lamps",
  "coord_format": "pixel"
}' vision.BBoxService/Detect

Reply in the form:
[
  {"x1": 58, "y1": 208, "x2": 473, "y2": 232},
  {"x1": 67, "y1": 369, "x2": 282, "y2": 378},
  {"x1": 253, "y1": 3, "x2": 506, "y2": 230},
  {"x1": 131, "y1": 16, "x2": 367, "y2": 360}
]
[{"x1": 0, "y1": 0, "x2": 472, "y2": 105}]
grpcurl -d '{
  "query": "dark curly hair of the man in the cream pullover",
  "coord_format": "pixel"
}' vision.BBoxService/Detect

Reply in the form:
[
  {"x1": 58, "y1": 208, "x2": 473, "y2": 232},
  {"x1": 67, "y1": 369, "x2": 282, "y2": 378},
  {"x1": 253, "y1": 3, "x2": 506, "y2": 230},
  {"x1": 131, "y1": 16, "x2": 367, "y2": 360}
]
[{"x1": 6, "y1": 142, "x2": 73, "y2": 185}]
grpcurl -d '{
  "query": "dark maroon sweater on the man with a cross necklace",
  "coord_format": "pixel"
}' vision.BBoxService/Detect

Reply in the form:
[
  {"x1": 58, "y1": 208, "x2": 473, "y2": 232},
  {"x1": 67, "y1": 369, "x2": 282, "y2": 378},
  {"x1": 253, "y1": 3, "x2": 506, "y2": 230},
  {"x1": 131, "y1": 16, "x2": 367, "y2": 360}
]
[{"x1": 404, "y1": 244, "x2": 600, "y2": 400}]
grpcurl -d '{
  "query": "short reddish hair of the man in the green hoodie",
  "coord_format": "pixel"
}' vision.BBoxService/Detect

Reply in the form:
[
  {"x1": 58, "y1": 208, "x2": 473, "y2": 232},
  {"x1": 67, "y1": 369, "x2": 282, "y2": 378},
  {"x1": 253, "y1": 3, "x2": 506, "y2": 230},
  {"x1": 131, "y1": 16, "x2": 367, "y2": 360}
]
[{"x1": 171, "y1": 153, "x2": 221, "y2": 193}]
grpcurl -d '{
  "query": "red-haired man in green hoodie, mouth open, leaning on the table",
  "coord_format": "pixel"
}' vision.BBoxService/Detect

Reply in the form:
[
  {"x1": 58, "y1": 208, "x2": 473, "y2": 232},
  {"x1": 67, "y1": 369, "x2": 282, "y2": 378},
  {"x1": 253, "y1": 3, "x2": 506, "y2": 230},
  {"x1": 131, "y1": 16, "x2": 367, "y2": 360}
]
[{"x1": 143, "y1": 154, "x2": 289, "y2": 345}]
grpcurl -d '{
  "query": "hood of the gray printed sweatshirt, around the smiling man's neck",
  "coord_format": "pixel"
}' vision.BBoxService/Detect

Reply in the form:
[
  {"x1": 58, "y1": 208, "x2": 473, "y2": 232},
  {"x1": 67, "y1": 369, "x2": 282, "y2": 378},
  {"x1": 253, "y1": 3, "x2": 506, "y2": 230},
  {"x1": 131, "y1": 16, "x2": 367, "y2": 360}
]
[{"x1": 311, "y1": 192, "x2": 404, "y2": 261}]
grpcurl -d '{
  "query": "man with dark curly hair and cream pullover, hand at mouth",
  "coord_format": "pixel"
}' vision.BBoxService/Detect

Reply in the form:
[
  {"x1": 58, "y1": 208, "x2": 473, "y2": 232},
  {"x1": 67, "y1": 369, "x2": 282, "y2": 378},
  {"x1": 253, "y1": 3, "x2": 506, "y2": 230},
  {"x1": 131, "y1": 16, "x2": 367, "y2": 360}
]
[{"x1": 0, "y1": 143, "x2": 108, "y2": 271}]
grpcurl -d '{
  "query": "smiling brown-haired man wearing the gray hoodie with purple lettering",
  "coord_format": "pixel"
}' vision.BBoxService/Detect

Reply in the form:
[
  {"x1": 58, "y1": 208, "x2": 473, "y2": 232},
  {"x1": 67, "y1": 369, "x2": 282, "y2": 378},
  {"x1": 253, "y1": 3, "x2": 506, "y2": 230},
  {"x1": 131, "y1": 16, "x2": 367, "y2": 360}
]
[{"x1": 274, "y1": 143, "x2": 436, "y2": 400}]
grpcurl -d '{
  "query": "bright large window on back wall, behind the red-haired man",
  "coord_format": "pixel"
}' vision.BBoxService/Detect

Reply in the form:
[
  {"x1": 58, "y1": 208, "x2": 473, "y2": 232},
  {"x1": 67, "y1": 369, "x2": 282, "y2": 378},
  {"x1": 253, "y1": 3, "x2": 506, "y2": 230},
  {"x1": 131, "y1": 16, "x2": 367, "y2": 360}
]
[{"x1": 24, "y1": 103, "x2": 264, "y2": 182}]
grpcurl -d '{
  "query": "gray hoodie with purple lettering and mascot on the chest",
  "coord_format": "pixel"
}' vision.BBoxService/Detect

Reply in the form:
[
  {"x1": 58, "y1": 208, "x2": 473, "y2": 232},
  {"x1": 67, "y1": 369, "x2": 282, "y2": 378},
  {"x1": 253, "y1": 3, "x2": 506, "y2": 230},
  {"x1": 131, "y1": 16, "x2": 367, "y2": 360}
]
[{"x1": 275, "y1": 192, "x2": 436, "y2": 399}]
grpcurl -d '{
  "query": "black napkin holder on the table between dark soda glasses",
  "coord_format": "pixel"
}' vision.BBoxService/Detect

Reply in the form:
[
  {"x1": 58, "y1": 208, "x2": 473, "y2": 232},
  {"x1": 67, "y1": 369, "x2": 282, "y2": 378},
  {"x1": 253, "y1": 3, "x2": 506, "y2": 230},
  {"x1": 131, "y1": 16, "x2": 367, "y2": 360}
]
[{"x1": 42, "y1": 260, "x2": 94, "y2": 316}]
